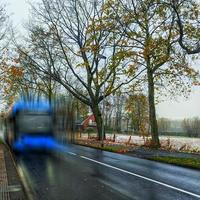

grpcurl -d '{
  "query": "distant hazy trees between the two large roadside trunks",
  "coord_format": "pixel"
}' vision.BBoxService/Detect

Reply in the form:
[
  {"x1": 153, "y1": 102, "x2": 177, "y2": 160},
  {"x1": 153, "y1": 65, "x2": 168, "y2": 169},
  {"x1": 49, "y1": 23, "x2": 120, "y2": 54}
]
[{"x1": 96, "y1": 91, "x2": 149, "y2": 135}]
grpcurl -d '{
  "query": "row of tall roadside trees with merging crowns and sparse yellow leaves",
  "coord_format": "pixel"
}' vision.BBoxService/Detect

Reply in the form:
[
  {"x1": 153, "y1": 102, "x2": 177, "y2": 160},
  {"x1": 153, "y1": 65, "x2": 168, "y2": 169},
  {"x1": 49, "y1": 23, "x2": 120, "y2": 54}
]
[{"x1": 0, "y1": 0, "x2": 200, "y2": 147}]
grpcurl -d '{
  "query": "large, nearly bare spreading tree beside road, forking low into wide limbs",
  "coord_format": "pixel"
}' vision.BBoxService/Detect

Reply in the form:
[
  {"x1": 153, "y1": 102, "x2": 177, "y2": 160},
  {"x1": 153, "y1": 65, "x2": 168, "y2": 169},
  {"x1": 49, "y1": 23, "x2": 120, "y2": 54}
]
[{"x1": 17, "y1": 0, "x2": 142, "y2": 139}]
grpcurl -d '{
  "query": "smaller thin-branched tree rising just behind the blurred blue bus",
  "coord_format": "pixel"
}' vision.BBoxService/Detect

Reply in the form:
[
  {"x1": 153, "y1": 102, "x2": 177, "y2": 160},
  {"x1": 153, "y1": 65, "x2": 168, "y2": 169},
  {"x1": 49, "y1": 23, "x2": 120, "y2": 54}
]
[{"x1": 18, "y1": 23, "x2": 61, "y2": 104}]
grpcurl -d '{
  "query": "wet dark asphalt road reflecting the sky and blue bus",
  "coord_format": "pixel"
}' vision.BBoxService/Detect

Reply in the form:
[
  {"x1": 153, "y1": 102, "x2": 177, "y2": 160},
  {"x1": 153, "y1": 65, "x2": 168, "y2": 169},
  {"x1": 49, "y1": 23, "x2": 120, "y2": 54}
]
[{"x1": 17, "y1": 145, "x2": 200, "y2": 200}]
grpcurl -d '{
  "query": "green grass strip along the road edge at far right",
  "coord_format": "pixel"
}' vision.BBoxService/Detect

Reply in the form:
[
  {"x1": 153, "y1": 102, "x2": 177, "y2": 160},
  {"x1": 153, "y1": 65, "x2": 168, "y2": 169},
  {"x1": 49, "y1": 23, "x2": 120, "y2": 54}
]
[{"x1": 149, "y1": 156, "x2": 200, "y2": 169}]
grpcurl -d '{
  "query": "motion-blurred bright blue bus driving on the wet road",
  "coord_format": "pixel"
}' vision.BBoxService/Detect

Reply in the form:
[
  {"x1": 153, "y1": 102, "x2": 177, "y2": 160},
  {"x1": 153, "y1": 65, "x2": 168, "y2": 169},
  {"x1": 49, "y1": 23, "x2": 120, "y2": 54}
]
[{"x1": 5, "y1": 100, "x2": 54, "y2": 151}]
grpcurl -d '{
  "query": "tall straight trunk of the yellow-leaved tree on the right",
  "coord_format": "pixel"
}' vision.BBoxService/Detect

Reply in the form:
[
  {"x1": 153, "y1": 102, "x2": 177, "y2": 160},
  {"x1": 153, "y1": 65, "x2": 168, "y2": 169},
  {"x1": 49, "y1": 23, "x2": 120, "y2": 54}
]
[{"x1": 147, "y1": 69, "x2": 160, "y2": 148}]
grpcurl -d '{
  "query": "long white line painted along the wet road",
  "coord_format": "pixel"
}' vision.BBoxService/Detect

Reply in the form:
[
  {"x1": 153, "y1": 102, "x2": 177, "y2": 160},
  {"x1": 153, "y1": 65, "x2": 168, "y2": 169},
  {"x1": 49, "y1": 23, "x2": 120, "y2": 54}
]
[{"x1": 80, "y1": 156, "x2": 200, "y2": 198}]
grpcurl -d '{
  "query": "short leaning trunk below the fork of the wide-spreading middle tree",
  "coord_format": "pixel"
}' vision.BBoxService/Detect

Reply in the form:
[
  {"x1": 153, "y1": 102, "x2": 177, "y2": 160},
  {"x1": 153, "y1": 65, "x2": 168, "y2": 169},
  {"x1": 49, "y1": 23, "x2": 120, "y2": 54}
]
[{"x1": 91, "y1": 104, "x2": 105, "y2": 140}]
